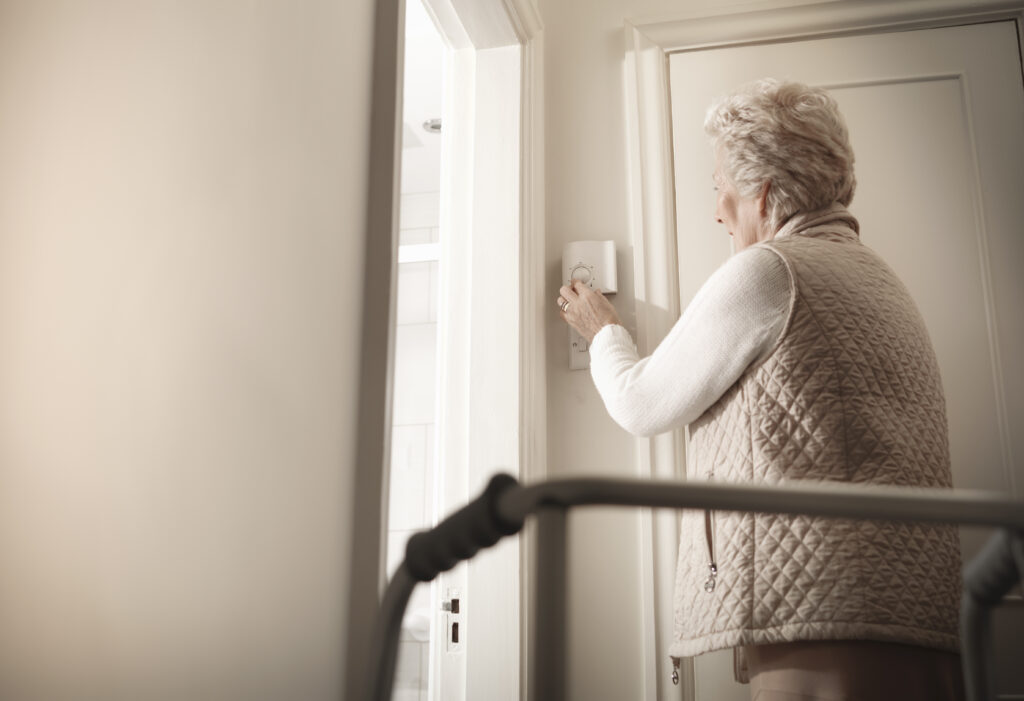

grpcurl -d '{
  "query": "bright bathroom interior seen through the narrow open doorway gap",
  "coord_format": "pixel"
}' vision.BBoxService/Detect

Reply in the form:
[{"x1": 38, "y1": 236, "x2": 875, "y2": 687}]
[{"x1": 387, "y1": 0, "x2": 445, "y2": 701}]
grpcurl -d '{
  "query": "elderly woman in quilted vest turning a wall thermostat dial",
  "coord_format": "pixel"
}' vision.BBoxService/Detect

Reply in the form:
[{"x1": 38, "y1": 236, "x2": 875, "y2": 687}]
[{"x1": 557, "y1": 80, "x2": 963, "y2": 701}]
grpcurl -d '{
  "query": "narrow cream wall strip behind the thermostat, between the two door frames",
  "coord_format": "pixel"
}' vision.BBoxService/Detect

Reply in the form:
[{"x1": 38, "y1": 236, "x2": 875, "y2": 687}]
[{"x1": 539, "y1": 0, "x2": 819, "y2": 699}]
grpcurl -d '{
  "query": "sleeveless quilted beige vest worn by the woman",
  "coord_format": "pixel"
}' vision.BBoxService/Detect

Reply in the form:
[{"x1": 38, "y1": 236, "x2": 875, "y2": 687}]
[{"x1": 670, "y1": 214, "x2": 961, "y2": 657}]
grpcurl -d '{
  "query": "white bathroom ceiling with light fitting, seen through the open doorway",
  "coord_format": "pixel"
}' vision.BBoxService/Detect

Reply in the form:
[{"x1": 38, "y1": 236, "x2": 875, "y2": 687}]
[{"x1": 401, "y1": 0, "x2": 444, "y2": 193}]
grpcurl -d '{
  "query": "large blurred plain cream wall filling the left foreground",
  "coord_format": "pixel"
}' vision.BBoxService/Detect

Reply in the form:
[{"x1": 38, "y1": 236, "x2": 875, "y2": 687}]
[{"x1": 0, "y1": 0, "x2": 386, "y2": 701}]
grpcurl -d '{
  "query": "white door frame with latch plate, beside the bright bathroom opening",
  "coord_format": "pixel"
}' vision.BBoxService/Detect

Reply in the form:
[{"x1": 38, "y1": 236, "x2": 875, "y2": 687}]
[{"x1": 413, "y1": 0, "x2": 547, "y2": 701}]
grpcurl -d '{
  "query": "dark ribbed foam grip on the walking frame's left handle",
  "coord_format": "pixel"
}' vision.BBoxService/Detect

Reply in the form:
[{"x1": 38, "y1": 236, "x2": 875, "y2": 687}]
[{"x1": 406, "y1": 474, "x2": 523, "y2": 581}]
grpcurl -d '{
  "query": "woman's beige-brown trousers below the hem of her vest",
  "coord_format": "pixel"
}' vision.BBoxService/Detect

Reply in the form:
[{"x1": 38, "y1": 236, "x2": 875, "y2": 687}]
[{"x1": 743, "y1": 641, "x2": 965, "y2": 701}]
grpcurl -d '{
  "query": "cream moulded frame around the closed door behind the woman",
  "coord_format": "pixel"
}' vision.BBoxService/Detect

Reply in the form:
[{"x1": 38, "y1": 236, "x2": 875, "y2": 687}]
[{"x1": 625, "y1": 0, "x2": 1024, "y2": 701}]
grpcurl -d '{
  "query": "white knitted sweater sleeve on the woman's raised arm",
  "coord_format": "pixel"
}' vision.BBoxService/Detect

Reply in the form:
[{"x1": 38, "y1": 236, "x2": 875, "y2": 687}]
[{"x1": 590, "y1": 247, "x2": 793, "y2": 436}]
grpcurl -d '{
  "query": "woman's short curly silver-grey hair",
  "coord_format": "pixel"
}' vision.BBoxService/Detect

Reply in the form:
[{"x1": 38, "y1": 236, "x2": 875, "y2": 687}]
[{"x1": 705, "y1": 78, "x2": 857, "y2": 233}]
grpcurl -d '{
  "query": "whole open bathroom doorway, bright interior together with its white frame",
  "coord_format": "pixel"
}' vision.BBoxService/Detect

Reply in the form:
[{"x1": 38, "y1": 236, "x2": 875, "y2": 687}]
[{"x1": 385, "y1": 0, "x2": 546, "y2": 701}]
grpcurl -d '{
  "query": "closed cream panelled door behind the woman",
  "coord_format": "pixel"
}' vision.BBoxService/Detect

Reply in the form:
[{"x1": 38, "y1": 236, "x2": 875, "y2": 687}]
[{"x1": 670, "y1": 21, "x2": 1024, "y2": 701}]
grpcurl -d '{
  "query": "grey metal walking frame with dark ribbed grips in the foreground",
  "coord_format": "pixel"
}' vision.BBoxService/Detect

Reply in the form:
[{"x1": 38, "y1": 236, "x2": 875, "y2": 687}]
[{"x1": 366, "y1": 474, "x2": 1024, "y2": 701}]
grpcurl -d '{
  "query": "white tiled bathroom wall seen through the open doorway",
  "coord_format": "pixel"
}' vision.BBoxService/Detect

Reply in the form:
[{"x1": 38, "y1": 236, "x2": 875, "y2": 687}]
[{"x1": 387, "y1": 192, "x2": 439, "y2": 701}]
